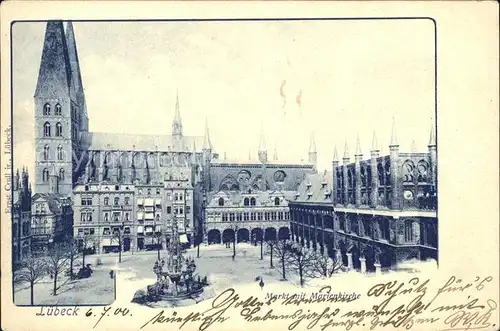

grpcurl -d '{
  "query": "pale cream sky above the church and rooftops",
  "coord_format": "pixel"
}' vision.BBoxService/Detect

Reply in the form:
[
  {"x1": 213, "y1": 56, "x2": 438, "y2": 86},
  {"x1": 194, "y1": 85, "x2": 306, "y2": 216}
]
[{"x1": 12, "y1": 20, "x2": 434, "y2": 180}]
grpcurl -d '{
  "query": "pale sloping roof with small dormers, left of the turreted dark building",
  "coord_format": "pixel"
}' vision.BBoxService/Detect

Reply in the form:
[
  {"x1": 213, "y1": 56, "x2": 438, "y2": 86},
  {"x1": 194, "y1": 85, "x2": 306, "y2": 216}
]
[{"x1": 292, "y1": 171, "x2": 333, "y2": 204}]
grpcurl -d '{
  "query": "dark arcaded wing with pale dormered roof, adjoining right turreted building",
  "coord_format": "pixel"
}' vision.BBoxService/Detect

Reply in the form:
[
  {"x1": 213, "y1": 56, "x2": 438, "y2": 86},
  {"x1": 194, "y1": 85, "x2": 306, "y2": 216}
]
[{"x1": 288, "y1": 171, "x2": 335, "y2": 257}]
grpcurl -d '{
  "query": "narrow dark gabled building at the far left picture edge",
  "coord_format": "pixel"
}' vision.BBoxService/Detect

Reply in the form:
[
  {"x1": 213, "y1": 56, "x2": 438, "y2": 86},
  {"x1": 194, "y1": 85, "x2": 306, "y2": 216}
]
[{"x1": 12, "y1": 168, "x2": 31, "y2": 264}]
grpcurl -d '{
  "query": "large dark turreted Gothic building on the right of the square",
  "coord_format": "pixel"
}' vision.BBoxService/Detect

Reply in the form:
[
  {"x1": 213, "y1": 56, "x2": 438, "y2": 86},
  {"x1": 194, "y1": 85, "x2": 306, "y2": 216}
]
[{"x1": 333, "y1": 127, "x2": 438, "y2": 271}]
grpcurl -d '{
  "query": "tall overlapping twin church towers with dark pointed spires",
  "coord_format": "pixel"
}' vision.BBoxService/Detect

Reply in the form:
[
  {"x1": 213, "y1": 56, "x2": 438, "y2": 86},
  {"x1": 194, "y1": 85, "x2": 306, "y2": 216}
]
[{"x1": 34, "y1": 21, "x2": 88, "y2": 196}]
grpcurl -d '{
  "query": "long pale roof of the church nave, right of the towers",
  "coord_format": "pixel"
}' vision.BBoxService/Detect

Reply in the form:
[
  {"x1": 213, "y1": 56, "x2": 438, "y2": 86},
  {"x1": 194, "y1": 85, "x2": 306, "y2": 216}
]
[{"x1": 81, "y1": 132, "x2": 203, "y2": 152}]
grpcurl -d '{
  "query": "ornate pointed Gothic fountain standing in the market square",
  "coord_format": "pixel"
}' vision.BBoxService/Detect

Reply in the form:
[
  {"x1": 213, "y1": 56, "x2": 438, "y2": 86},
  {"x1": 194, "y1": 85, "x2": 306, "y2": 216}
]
[{"x1": 132, "y1": 217, "x2": 214, "y2": 307}]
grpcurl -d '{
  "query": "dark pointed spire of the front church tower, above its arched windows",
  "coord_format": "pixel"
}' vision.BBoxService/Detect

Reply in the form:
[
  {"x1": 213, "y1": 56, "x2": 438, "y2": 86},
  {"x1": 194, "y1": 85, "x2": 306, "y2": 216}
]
[{"x1": 35, "y1": 21, "x2": 71, "y2": 98}]
